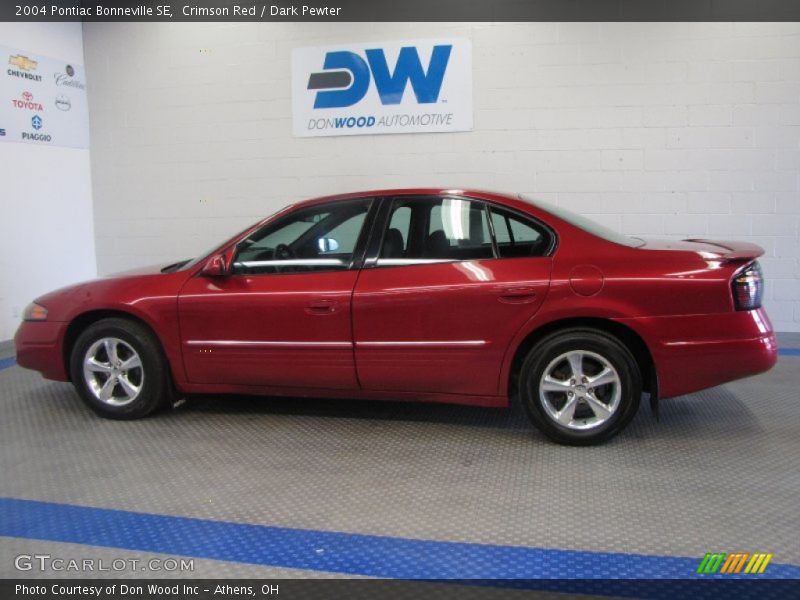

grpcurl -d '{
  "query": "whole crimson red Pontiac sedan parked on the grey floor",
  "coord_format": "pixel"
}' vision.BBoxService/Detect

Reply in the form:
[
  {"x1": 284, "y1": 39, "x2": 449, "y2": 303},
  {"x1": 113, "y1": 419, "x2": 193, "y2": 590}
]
[{"x1": 16, "y1": 189, "x2": 777, "y2": 444}]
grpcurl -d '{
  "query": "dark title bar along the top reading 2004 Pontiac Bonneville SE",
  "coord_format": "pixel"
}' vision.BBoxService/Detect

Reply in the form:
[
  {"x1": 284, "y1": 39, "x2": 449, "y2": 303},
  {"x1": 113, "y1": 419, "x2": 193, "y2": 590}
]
[{"x1": 0, "y1": 0, "x2": 800, "y2": 22}]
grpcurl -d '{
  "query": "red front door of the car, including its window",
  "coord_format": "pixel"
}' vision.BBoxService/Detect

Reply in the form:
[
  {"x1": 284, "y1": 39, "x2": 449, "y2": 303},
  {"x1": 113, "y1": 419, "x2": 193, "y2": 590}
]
[{"x1": 178, "y1": 198, "x2": 373, "y2": 389}]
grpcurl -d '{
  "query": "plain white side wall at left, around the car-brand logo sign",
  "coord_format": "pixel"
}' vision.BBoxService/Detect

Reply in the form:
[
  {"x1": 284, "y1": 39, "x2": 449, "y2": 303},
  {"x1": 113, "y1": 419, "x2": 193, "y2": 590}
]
[{"x1": 0, "y1": 23, "x2": 97, "y2": 341}]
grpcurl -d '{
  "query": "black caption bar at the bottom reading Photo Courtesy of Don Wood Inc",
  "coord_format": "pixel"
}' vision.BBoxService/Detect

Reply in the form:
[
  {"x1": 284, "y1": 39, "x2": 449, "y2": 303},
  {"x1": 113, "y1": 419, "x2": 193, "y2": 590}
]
[{"x1": 0, "y1": 578, "x2": 800, "y2": 600}]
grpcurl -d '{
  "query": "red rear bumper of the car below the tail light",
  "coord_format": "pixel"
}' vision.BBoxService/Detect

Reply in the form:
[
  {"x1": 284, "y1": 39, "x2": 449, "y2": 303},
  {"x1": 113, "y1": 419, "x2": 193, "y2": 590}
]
[{"x1": 622, "y1": 309, "x2": 778, "y2": 398}]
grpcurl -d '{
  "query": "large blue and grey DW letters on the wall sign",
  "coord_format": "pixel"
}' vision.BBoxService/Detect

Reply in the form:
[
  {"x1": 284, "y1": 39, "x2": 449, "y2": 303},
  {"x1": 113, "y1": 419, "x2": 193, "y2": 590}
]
[{"x1": 306, "y1": 44, "x2": 453, "y2": 109}]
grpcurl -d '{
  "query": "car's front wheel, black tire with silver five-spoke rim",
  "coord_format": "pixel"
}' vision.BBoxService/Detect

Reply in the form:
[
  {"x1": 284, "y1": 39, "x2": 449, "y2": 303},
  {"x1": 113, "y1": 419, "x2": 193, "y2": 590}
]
[{"x1": 70, "y1": 318, "x2": 174, "y2": 419}]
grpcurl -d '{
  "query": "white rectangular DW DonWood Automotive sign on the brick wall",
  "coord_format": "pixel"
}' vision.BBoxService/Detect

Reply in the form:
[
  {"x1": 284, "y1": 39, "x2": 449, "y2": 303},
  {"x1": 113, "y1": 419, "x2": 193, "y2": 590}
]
[{"x1": 292, "y1": 39, "x2": 472, "y2": 137}]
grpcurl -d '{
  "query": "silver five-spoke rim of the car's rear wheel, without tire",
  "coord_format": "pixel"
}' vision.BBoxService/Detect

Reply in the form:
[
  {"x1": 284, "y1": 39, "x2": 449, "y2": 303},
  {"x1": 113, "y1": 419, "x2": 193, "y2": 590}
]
[{"x1": 539, "y1": 350, "x2": 622, "y2": 431}]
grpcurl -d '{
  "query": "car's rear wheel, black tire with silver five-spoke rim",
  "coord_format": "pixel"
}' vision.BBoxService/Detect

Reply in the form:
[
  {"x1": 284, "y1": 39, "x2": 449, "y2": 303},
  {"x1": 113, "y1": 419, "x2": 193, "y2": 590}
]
[{"x1": 519, "y1": 328, "x2": 642, "y2": 446}]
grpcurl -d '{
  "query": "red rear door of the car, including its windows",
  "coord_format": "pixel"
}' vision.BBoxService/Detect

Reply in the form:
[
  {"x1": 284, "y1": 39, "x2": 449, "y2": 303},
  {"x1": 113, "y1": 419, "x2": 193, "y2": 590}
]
[{"x1": 353, "y1": 196, "x2": 554, "y2": 396}]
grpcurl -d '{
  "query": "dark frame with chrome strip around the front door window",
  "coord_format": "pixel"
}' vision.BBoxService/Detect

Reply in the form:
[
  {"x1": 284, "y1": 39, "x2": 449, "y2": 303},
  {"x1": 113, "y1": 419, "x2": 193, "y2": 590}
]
[{"x1": 230, "y1": 196, "x2": 381, "y2": 277}]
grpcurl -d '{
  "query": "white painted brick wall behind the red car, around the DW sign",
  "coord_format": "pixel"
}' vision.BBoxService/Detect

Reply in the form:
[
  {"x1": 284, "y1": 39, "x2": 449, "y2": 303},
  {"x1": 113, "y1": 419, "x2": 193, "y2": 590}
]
[{"x1": 84, "y1": 23, "x2": 800, "y2": 331}]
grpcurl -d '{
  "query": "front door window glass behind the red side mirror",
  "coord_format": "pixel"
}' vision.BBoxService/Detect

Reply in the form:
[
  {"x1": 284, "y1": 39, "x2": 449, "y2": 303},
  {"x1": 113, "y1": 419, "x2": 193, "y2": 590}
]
[{"x1": 232, "y1": 198, "x2": 372, "y2": 275}]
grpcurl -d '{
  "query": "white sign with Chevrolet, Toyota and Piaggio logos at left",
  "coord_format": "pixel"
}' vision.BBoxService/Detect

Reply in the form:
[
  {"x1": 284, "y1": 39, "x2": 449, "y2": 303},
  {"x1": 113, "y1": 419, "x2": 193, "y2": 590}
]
[{"x1": 0, "y1": 46, "x2": 89, "y2": 148}]
